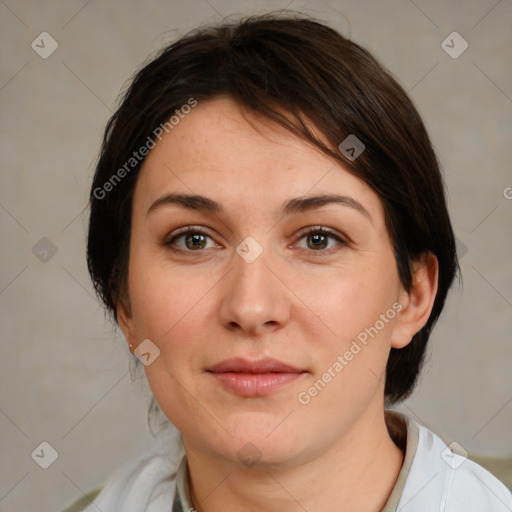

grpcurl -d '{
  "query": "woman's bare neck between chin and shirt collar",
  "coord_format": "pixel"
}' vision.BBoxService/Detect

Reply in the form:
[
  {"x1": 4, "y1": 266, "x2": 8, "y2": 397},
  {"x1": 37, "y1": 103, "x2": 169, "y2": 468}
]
[{"x1": 186, "y1": 408, "x2": 404, "y2": 512}]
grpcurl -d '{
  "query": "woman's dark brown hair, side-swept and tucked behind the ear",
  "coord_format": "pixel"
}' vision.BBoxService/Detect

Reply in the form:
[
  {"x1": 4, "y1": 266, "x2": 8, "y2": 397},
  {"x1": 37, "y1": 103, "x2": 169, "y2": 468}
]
[{"x1": 87, "y1": 13, "x2": 458, "y2": 403}]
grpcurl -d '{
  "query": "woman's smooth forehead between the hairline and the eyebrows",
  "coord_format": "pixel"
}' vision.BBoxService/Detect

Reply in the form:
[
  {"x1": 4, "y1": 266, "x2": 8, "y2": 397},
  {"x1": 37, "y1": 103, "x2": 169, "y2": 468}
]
[{"x1": 136, "y1": 98, "x2": 382, "y2": 222}]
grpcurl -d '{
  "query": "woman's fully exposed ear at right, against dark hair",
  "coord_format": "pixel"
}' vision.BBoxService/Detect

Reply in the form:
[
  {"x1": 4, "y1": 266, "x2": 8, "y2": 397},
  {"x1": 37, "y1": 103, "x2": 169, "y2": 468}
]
[{"x1": 391, "y1": 252, "x2": 439, "y2": 348}]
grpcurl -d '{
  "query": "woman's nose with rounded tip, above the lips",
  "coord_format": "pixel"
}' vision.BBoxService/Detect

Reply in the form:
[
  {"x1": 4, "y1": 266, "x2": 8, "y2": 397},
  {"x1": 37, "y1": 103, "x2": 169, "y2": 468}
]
[{"x1": 220, "y1": 240, "x2": 292, "y2": 336}]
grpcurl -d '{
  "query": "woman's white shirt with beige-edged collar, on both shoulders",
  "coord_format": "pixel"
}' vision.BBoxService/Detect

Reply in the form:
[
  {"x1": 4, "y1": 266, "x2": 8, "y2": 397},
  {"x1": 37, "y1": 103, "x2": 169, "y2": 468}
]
[{"x1": 80, "y1": 411, "x2": 512, "y2": 512}]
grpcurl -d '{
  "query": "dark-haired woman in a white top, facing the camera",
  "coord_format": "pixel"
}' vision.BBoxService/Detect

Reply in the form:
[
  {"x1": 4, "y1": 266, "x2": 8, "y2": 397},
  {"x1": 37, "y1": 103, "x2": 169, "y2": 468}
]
[{"x1": 75, "y1": 15, "x2": 512, "y2": 512}]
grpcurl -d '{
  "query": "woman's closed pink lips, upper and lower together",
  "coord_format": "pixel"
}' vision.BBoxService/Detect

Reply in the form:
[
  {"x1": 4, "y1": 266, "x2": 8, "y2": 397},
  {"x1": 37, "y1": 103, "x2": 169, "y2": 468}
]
[{"x1": 206, "y1": 358, "x2": 307, "y2": 397}]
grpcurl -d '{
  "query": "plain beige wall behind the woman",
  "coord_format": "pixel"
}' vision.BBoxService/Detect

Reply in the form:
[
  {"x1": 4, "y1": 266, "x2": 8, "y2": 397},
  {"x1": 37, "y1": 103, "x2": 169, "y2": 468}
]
[{"x1": 0, "y1": 0, "x2": 512, "y2": 512}]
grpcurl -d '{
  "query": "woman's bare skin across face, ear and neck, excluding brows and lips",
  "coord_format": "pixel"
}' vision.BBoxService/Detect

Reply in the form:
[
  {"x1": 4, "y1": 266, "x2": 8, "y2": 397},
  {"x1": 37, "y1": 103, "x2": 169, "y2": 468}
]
[{"x1": 117, "y1": 98, "x2": 437, "y2": 512}]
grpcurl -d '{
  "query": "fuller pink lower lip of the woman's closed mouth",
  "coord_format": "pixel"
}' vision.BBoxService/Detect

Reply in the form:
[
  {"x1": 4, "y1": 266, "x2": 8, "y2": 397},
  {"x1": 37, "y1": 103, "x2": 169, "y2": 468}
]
[{"x1": 211, "y1": 372, "x2": 302, "y2": 396}]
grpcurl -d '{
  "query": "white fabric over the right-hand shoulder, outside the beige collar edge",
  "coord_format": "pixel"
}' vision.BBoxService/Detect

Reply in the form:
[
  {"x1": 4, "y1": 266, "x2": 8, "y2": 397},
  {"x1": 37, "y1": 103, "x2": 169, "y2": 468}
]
[{"x1": 398, "y1": 418, "x2": 512, "y2": 512}]
